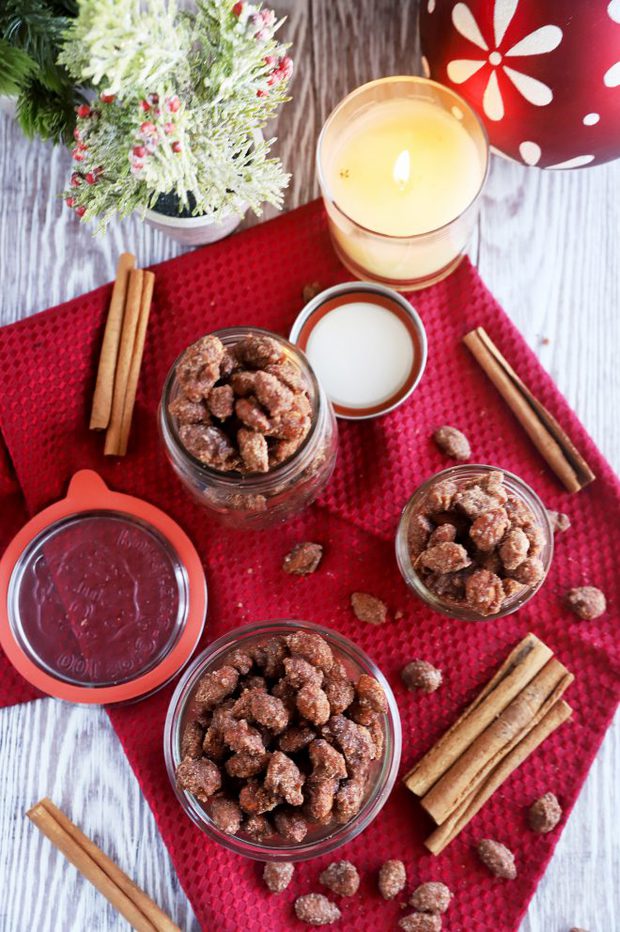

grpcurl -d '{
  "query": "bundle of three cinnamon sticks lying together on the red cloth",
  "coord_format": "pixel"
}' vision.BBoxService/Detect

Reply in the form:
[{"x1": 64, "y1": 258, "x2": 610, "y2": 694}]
[{"x1": 405, "y1": 634, "x2": 574, "y2": 854}]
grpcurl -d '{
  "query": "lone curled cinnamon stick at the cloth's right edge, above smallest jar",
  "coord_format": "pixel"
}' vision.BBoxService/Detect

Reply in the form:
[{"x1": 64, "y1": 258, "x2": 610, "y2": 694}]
[{"x1": 463, "y1": 327, "x2": 595, "y2": 492}]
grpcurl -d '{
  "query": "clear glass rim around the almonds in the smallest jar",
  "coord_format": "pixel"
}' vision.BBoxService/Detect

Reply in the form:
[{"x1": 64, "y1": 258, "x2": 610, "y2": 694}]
[{"x1": 395, "y1": 463, "x2": 554, "y2": 622}]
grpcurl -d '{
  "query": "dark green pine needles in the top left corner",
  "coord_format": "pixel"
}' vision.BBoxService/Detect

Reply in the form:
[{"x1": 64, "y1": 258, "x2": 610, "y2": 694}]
[{"x1": 0, "y1": 0, "x2": 84, "y2": 143}]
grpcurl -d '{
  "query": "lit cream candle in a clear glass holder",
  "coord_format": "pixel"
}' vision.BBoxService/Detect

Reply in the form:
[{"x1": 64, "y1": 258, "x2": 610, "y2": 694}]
[{"x1": 317, "y1": 76, "x2": 489, "y2": 291}]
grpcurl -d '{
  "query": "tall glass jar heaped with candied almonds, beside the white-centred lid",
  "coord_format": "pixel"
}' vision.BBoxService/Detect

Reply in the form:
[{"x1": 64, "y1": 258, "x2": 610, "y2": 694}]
[{"x1": 159, "y1": 327, "x2": 338, "y2": 528}]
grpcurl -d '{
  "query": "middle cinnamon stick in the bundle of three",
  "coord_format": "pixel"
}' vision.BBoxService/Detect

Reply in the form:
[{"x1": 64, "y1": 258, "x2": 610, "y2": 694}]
[{"x1": 422, "y1": 658, "x2": 574, "y2": 825}]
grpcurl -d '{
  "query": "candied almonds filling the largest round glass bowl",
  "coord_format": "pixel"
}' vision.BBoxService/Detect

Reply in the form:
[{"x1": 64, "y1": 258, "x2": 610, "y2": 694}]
[{"x1": 176, "y1": 631, "x2": 387, "y2": 843}]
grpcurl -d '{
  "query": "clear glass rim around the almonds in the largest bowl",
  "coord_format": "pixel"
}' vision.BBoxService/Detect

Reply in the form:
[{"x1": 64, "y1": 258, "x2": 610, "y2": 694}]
[{"x1": 164, "y1": 619, "x2": 402, "y2": 861}]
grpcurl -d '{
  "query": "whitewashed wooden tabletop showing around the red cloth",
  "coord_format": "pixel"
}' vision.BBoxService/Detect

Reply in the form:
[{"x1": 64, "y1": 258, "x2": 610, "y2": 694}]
[{"x1": 0, "y1": 0, "x2": 620, "y2": 932}]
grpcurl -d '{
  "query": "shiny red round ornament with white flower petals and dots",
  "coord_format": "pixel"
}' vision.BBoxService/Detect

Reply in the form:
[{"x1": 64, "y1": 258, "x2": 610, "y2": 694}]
[{"x1": 420, "y1": 0, "x2": 620, "y2": 168}]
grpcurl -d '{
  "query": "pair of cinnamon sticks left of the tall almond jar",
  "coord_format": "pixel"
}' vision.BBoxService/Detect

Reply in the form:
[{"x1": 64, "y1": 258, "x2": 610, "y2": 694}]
[{"x1": 90, "y1": 252, "x2": 155, "y2": 456}]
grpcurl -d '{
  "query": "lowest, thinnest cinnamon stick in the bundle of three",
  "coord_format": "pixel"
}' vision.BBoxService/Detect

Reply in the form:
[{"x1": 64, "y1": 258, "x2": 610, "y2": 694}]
[{"x1": 424, "y1": 700, "x2": 572, "y2": 854}]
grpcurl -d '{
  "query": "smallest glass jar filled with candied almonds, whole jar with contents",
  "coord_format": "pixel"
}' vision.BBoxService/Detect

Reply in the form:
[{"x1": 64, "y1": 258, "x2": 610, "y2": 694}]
[{"x1": 396, "y1": 464, "x2": 553, "y2": 621}]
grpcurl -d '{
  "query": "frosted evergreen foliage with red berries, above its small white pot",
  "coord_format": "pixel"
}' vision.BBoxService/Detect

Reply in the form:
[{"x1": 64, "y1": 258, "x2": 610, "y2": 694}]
[{"x1": 59, "y1": 0, "x2": 292, "y2": 228}]
